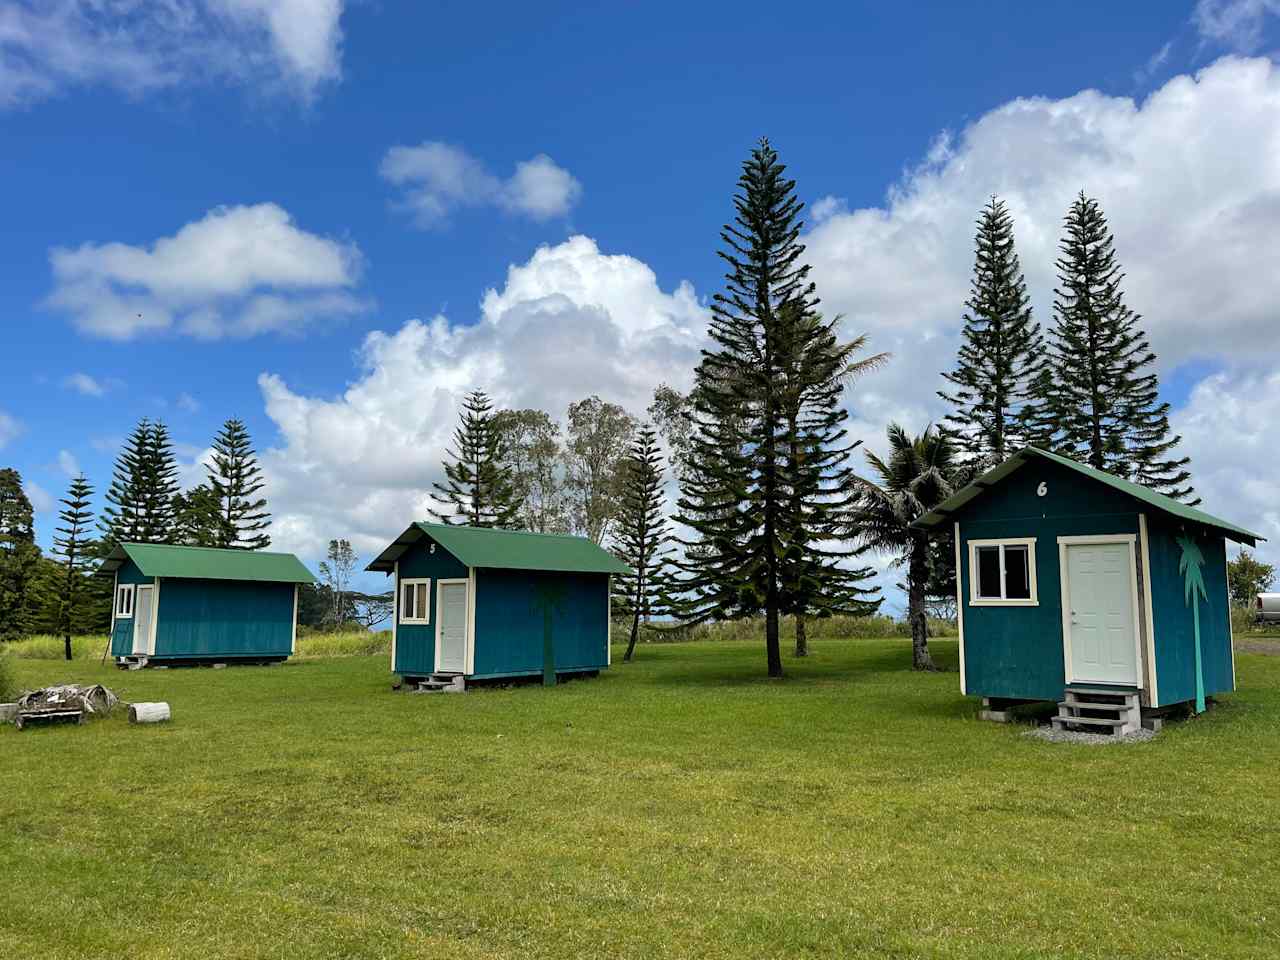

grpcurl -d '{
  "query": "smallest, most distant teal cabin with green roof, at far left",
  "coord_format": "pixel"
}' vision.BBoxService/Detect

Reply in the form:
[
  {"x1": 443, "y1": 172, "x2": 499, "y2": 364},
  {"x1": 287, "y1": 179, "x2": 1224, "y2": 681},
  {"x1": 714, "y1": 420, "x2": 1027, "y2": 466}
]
[{"x1": 97, "y1": 543, "x2": 315, "y2": 666}]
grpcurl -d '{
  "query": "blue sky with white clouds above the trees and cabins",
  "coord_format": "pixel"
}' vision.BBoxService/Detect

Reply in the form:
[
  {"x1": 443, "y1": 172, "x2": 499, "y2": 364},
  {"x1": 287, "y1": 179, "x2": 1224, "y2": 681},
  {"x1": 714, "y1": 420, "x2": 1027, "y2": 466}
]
[{"x1": 0, "y1": 0, "x2": 1280, "y2": 601}]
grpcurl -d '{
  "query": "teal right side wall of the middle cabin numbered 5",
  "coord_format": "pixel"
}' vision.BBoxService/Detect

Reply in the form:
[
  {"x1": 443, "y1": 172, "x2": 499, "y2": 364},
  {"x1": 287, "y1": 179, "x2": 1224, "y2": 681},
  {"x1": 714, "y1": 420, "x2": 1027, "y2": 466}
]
[{"x1": 474, "y1": 570, "x2": 609, "y2": 677}]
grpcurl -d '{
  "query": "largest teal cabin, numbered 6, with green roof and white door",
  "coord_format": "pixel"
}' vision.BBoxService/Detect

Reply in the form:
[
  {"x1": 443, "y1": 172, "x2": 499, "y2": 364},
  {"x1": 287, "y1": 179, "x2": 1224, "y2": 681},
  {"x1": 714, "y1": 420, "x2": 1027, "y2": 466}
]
[{"x1": 915, "y1": 447, "x2": 1262, "y2": 716}]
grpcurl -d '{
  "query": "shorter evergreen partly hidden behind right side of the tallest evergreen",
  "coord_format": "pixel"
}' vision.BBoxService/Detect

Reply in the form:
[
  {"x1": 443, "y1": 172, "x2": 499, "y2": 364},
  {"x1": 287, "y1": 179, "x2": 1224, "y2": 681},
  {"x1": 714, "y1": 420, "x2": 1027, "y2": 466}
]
[{"x1": 778, "y1": 306, "x2": 888, "y2": 657}]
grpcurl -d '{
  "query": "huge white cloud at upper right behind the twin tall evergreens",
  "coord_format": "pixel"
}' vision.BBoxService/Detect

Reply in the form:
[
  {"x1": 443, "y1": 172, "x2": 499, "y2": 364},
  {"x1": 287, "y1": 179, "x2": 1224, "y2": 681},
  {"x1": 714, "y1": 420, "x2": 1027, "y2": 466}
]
[{"x1": 805, "y1": 58, "x2": 1280, "y2": 455}]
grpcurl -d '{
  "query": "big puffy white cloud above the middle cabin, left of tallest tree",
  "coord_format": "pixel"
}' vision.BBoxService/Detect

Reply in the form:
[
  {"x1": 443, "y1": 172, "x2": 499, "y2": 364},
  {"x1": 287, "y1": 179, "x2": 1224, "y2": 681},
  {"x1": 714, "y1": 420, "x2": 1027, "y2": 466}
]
[{"x1": 259, "y1": 237, "x2": 707, "y2": 557}]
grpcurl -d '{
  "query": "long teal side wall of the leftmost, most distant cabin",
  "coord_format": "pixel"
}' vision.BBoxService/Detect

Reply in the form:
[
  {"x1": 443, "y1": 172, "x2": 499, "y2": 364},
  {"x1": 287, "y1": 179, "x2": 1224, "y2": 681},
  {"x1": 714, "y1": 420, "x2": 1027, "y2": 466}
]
[{"x1": 154, "y1": 579, "x2": 294, "y2": 659}]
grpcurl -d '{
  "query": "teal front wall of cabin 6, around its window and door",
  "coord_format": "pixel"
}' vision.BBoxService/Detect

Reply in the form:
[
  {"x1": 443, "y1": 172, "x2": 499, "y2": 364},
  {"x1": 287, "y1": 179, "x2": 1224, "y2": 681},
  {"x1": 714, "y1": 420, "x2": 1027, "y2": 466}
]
[{"x1": 954, "y1": 461, "x2": 1138, "y2": 700}]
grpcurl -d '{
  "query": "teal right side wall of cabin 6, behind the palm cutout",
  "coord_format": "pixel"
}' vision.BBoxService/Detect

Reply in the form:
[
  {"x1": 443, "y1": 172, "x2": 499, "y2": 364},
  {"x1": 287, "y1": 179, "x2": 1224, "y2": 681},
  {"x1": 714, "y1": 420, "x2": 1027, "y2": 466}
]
[{"x1": 1148, "y1": 516, "x2": 1235, "y2": 705}]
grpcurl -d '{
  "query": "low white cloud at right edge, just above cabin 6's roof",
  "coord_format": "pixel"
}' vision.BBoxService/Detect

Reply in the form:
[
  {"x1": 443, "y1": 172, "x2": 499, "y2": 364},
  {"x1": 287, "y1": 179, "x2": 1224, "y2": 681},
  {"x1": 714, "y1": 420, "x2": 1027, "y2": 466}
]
[{"x1": 1172, "y1": 364, "x2": 1280, "y2": 563}]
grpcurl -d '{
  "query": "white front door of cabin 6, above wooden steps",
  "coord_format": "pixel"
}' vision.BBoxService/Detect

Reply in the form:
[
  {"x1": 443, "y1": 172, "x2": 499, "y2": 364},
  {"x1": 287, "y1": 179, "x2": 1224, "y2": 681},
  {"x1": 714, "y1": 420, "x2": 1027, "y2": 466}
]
[{"x1": 1066, "y1": 543, "x2": 1138, "y2": 686}]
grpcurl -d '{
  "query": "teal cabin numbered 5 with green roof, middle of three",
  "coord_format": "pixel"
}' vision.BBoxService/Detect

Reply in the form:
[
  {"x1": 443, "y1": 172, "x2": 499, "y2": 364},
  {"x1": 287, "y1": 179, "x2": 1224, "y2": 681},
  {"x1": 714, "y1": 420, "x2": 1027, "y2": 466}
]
[{"x1": 367, "y1": 524, "x2": 630, "y2": 684}]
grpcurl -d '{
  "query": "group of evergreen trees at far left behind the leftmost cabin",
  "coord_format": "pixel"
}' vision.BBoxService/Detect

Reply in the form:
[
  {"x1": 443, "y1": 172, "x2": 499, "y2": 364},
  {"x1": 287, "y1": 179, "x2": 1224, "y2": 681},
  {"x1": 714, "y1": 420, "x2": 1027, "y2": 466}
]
[{"x1": 0, "y1": 419, "x2": 271, "y2": 659}]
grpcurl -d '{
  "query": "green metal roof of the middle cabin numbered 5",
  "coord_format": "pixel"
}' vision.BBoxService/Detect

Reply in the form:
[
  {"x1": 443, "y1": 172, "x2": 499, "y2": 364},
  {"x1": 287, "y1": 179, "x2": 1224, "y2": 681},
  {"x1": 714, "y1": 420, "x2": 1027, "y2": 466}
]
[{"x1": 366, "y1": 524, "x2": 631, "y2": 573}]
